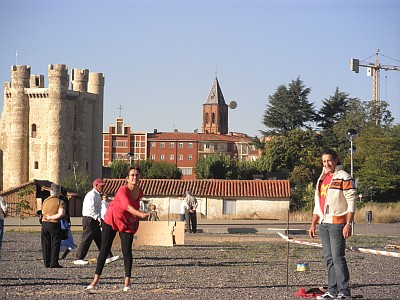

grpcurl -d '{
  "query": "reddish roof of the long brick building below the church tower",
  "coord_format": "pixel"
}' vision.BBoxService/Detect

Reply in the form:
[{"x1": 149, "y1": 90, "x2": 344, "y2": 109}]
[{"x1": 148, "y1": 132, "x2": 251, "y2": 142}]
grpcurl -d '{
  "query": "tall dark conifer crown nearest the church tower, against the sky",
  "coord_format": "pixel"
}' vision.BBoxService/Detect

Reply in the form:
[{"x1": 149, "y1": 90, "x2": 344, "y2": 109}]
[{"x1": 261, "y1": 78, "x2": 315, "y2": 135}]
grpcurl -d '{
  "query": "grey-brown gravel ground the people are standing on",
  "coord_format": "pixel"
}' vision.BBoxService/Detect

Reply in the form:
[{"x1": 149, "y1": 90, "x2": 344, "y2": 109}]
[{"x1": 0, "y1": 232, "x2": 400, "y2": 300}]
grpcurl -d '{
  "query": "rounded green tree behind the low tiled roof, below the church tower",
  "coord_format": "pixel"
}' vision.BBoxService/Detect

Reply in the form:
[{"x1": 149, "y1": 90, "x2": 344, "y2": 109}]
[{"x1": 195, "y1": 153, "x2": 237, "y2": 179}]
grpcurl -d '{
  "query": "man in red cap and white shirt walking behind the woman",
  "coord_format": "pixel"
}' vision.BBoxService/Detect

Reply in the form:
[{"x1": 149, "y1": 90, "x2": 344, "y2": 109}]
[{"x1": 74, "y1": 178, "x2": 119, "y2": 265}]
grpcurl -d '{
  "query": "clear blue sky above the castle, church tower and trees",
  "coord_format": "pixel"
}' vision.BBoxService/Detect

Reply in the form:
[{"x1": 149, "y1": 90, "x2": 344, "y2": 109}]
[{"x1": 0, "y1": 0, "x2": 400, "y2": 136}]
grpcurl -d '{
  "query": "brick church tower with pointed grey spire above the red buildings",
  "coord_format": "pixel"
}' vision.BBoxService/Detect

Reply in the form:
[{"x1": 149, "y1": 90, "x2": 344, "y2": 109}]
[{"x1": 202, "y1": 77, "x2": 228, "y2": 134}]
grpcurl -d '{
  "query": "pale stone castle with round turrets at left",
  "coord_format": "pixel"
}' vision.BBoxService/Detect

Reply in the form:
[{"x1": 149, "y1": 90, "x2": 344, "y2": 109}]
[{"x1": 0, "y1": 64, "x2": 104, "y2": 190}]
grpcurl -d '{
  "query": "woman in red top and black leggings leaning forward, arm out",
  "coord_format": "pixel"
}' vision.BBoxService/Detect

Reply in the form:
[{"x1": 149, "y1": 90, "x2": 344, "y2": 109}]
[{"x1": 86, "y1": 167, "x2": 149, "y2": 292}]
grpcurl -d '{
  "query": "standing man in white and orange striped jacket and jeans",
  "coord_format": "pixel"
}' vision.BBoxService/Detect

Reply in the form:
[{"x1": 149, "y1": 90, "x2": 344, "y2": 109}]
[{"x1": 309, "y1": 149, "x2": 357, "y2": 299}]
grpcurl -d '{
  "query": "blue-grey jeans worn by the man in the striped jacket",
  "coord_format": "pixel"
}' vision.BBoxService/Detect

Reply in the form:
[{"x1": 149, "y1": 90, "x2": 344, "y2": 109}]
[{"x1": 319, "y1": 224, "x2": 350, "y2": 296}]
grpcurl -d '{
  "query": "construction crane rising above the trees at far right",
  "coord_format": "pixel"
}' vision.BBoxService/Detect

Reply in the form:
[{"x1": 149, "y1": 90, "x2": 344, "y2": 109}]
[{"x1": 350, "y1": 49, "x2": 400, "y2": 124}]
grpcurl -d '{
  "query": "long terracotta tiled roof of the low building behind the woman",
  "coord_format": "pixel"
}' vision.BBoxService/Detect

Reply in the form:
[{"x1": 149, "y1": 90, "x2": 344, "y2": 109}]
[{"x1": 103, "y1": 179, "x2": 290, "y2": 198}]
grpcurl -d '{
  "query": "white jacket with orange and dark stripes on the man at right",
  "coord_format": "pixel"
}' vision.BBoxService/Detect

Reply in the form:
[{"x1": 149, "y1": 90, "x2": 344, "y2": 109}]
[{"x1": 313, "y1": 165, "x2": 357, "y2": 224}]
